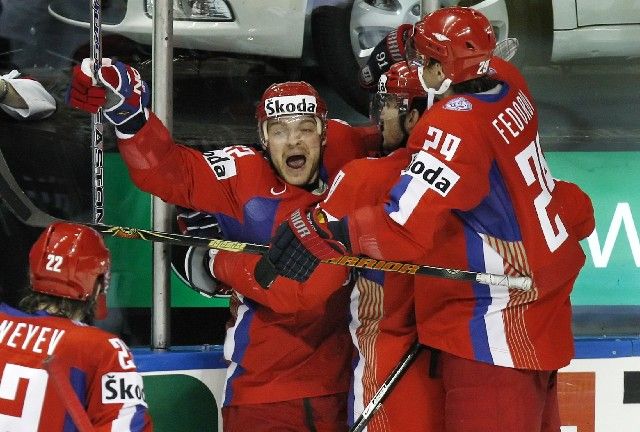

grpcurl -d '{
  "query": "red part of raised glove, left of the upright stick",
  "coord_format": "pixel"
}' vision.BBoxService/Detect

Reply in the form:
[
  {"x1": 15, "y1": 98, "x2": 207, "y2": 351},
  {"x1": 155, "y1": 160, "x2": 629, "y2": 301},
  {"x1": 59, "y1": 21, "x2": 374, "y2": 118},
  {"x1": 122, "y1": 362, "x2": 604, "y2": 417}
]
[{"x1": 66, "y1": 59, "x2": 111, "y2": 114}]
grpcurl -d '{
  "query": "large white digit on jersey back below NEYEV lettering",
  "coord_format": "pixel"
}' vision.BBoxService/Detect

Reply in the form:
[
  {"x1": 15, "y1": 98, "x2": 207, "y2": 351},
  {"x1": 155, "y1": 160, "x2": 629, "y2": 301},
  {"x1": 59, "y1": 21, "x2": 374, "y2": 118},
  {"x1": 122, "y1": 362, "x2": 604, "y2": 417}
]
[{"x1": 0, "y1": 363, "x2": 49, "y2": 432}]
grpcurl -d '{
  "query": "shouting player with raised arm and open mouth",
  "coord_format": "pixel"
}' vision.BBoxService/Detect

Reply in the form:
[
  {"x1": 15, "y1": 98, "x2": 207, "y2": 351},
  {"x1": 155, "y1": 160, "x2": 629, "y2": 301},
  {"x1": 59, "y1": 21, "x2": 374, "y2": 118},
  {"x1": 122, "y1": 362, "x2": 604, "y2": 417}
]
[{"x1": 71, "y1": 62, "x2": 379, "y2": 432}]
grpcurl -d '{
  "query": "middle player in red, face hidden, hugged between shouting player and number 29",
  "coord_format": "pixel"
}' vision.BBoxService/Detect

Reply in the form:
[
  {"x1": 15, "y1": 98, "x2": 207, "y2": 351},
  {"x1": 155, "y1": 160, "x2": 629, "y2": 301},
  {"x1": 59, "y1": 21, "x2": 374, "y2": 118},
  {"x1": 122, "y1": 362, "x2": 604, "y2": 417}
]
[{"x1": 182, "y1": 62, "x2": 444, "y2": 432}]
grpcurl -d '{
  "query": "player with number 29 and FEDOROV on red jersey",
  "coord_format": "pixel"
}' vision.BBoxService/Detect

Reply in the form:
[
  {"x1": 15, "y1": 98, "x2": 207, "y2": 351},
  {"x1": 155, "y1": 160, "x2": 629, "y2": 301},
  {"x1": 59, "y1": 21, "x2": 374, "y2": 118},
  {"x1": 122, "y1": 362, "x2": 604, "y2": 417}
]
[{"x1": 260, "y1": 7, "x2": 594, "y2": 432}]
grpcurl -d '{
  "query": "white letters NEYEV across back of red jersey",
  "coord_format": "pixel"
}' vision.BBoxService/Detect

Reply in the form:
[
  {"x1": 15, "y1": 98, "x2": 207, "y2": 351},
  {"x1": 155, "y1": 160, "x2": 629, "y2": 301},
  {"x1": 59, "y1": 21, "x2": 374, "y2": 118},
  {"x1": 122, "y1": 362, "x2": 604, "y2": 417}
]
[{"x1": 0, "y1": 320, "x2": 65, "y2": 355}]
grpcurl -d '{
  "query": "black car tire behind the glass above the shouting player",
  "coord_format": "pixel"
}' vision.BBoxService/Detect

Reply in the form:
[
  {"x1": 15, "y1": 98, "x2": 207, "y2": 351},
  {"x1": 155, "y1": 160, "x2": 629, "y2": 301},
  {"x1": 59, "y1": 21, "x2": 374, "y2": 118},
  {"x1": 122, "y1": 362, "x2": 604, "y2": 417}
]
[{"x1": 311, "y1": 5, "x2": 369, "y2": 116}]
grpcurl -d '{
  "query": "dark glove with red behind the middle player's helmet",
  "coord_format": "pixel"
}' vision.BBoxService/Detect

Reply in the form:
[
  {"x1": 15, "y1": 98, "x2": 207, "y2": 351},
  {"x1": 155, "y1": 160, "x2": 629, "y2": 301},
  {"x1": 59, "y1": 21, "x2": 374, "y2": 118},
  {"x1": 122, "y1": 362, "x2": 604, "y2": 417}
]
[{"x1": 358, "y1": 24, "x2": 413, "y2": 91}]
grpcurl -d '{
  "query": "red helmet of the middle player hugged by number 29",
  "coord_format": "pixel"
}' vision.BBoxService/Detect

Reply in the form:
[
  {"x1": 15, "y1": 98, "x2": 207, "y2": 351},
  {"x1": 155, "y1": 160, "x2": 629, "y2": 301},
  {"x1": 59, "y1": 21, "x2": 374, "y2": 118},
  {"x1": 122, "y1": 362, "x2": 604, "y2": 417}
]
[{"x1": 369, "y1": 61, "x2": 427, "y2": 123}]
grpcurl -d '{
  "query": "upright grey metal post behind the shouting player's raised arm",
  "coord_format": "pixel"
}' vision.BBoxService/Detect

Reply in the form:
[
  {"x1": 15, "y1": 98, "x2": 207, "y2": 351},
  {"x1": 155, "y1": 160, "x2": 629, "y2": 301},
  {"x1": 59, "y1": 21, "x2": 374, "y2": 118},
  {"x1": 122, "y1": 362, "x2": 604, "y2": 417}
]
[{"x1": 151, "y1": 0, "x2": 173, "y2": 350}]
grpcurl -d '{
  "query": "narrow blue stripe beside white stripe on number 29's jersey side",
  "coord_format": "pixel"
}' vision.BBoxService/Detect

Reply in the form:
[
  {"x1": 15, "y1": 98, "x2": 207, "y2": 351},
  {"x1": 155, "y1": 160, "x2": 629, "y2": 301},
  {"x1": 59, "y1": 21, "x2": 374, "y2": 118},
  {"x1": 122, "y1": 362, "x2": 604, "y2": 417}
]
[{"x1": 464, "y1": 225, "x2": 493, "y2": 364}]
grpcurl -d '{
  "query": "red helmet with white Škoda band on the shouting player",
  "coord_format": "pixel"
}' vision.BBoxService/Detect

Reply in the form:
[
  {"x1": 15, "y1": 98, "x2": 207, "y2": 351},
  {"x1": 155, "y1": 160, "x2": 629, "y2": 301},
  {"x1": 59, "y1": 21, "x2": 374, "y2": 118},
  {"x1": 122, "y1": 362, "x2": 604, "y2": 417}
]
[{"x1": 256, "y1": 81, "x2": 327, "y2": 147}]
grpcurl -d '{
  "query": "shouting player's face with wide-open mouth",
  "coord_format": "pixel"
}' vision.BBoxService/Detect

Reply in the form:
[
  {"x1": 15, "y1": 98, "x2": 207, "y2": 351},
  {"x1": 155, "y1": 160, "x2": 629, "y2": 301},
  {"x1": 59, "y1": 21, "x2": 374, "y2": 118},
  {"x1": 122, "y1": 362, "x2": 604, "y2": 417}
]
[{"x1": 267, "y1": 116, "x2": 322, "y2": 186}]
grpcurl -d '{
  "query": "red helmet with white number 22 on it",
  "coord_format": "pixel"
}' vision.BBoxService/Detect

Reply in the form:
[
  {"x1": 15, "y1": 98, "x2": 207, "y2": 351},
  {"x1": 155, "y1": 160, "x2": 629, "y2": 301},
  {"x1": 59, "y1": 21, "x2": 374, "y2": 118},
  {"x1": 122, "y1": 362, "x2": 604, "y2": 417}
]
[{"x1": 29, "y1": 222, "x2": 111, "y2": 300}]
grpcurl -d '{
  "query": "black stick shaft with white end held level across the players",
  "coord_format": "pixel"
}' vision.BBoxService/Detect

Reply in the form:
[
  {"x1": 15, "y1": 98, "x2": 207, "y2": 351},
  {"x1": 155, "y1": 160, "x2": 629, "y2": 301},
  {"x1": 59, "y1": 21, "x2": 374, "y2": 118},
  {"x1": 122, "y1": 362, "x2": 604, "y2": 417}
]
[{"x1": 72, "y1": 223, "x2": 532, "y2": 291}]
